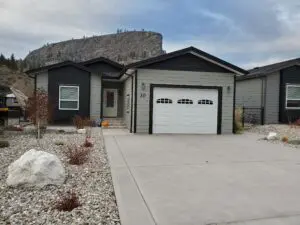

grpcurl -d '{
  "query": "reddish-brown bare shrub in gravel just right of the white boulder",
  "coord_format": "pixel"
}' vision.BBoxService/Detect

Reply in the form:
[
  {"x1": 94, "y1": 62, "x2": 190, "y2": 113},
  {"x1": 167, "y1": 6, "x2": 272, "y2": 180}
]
[{"x1": 66, "y1": 145, "x2": 91, "y2": 165}]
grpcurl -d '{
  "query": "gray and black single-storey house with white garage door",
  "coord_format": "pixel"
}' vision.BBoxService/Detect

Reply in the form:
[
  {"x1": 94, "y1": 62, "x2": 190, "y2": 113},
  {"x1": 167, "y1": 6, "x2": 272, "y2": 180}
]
[{"x1": 27, "y1": 47, "x2": 247, "y2": 134}]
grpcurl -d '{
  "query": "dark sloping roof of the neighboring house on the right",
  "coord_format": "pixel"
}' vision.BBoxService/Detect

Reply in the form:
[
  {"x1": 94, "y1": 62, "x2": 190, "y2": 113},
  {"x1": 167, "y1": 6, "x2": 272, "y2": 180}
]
[{"x1": 237, "y1": 58, "x2": 300, "y2": 80}]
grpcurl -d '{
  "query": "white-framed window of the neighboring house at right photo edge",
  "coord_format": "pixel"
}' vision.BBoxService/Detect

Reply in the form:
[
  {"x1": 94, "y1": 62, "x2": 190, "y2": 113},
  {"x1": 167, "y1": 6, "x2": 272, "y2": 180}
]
[{"x1": 285, "y1": 84, "x2": 300, "y2": 109}]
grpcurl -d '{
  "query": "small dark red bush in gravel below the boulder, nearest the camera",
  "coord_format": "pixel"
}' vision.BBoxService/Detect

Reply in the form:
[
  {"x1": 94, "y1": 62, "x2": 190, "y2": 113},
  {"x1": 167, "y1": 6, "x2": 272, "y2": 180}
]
[{"x1": 54, "y1": 191, "x2": 81, "y2": 212}]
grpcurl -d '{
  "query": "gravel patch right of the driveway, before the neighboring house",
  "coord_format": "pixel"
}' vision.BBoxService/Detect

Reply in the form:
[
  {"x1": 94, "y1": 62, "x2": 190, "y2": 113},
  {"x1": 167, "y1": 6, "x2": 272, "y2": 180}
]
[{"x1": 247, "y1": 124, "x2": 300, "y2": 148}]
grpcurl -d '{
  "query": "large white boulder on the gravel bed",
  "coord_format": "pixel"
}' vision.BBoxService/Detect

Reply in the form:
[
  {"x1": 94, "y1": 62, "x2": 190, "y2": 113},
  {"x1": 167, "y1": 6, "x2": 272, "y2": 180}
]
[{"x1": 6, "y1": 149, "x2": 65, "y2": 188}]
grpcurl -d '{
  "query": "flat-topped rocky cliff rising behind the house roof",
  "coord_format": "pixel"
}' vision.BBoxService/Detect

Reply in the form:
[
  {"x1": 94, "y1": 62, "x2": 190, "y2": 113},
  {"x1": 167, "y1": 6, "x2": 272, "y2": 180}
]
[{"x1": 25, "y1": 31, "x2": 164, "y2": 68}]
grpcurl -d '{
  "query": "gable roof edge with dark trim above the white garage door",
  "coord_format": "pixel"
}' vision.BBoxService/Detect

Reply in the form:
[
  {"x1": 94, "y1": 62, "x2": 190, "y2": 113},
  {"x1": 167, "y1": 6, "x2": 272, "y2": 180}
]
[{"x1": 126, "y1": 46, "x2": 248, "y2": 75}]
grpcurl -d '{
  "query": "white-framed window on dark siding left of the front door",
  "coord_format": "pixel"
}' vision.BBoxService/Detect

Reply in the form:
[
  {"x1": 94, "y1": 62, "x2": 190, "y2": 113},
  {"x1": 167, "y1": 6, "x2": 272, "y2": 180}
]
[{"x1": 59, "y1": 86, "x2": 79, "y2": 110}]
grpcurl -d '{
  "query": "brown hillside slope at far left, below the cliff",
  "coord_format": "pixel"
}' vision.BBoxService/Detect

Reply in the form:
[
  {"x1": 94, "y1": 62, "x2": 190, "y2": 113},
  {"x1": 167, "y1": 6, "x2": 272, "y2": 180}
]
[{"x1": 0, "y1": 66, "x2": 34, "y2": 96}]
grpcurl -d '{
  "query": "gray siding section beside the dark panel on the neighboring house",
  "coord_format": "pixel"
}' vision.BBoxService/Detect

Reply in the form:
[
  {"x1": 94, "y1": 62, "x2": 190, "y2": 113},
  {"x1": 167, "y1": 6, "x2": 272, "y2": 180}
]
[{"x1": 265, "y1": 72, "x2": 280, "y2": 124}]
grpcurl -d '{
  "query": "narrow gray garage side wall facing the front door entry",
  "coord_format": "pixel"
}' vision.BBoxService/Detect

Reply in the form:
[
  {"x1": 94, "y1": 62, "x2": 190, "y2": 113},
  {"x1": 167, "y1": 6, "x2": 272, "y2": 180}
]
[{"x1": 123, "y1": 77, "x2": 132, "y2": 129}]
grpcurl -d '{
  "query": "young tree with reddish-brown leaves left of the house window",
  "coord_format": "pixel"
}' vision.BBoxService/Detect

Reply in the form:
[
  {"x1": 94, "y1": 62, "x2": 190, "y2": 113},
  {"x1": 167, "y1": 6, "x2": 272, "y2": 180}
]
[{"x1": 26, "y1": 89, "x2": 52, "y2": 139}]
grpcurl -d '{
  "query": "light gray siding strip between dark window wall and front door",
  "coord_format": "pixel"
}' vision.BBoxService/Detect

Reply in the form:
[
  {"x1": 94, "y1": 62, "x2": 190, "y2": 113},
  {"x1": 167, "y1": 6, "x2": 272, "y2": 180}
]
[{"x1": 90, "y1": 74, "x2": 101, "y2": 119}]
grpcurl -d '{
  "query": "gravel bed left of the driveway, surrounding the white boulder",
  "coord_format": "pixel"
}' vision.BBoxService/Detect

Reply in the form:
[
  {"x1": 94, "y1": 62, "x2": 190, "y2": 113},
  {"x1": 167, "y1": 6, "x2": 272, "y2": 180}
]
[{"x1": 0, "y1": 128, "x2": 120, "y2": 225}]
